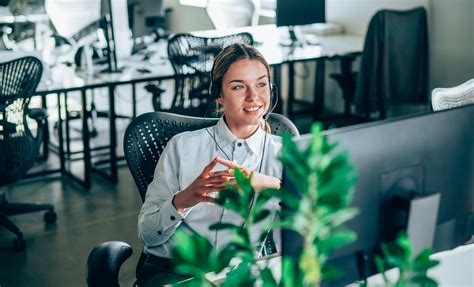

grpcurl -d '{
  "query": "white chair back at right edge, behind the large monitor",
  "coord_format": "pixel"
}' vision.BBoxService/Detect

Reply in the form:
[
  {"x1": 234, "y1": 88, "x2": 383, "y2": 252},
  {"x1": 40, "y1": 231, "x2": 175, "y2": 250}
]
[{"x1": 431, "y1": 79, "x2": 474, "y2": 111}]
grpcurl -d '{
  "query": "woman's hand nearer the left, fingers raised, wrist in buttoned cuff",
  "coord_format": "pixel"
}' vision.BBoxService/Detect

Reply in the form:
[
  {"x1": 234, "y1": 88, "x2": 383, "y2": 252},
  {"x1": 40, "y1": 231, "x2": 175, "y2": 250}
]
[{"x1": 173, "y1": 158, "x2": 230, "y2": 212}]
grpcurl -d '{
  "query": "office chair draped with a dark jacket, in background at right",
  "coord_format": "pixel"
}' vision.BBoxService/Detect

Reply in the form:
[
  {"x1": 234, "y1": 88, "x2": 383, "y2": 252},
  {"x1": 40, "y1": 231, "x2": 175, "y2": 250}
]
[{"x1": 332, "y1": 7, "x2": 429, "y2": 120}]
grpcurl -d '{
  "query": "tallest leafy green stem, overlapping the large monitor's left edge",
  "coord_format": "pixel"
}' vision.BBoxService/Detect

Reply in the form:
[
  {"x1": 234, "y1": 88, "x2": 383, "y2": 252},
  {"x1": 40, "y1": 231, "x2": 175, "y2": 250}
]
[{"x1": 280, "y1": 124, "x2": 357, "y2": 286}]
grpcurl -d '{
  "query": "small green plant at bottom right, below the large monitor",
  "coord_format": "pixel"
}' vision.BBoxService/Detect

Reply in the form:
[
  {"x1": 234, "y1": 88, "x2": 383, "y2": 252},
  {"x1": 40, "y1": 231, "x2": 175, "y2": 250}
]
[{"x1": 375, "y1": 232, "x2": 439, "y2": 287}]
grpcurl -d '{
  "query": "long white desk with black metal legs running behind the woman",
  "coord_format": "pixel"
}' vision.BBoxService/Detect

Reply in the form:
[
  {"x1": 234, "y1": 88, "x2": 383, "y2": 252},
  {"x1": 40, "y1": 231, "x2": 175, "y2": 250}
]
[{"x1": 37, "y1": 25, "x2": 363, "y2": 188}]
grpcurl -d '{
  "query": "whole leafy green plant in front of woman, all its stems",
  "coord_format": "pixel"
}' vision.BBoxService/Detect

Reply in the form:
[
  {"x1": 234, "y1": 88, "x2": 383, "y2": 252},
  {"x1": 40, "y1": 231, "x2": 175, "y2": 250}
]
[{"x1": 173, "y1": 124, "x2": 357, "y2": 286}]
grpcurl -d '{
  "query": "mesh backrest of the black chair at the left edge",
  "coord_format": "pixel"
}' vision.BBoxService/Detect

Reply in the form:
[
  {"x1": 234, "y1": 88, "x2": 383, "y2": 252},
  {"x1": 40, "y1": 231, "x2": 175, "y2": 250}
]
[{"x1": 0, "y1": 57, "x2": 43, "y2": 185}]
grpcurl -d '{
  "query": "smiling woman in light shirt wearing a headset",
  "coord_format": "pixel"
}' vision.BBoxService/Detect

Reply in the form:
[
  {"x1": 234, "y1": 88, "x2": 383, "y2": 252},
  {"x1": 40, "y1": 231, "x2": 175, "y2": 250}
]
[{"x1": 138, "y1": 44, "x2": 282, "y2": 285}]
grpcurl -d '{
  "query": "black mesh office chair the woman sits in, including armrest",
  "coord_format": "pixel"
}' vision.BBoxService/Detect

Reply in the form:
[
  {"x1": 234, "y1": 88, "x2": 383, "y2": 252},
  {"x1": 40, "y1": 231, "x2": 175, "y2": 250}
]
[{"x1": 86, "y1": 112, "x2": 299, "y2": 287}]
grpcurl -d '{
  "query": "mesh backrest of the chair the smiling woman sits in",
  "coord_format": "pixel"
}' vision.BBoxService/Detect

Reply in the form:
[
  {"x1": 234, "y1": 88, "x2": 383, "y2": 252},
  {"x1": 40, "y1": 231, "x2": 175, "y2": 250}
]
[{"x1": 124, "y1": 112, "x2": 299, "y2": 201}]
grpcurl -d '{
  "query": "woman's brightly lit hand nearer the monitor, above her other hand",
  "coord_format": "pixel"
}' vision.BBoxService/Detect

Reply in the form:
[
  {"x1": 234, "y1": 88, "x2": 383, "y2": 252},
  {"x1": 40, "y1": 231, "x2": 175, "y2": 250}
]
[{"x1": 211, "y1": 157, "x2": 281, "y2": 192}]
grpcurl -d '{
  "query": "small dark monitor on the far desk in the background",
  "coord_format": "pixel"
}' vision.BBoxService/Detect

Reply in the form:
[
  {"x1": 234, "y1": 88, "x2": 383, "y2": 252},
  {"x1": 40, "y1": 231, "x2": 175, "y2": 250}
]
[{"x1": 276, "y1": 0, "x2": 326, "y2": 45}]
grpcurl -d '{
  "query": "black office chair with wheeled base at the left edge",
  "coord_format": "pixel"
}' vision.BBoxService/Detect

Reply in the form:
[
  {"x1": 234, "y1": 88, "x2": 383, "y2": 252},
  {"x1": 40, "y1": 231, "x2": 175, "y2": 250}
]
[{"x1": 0, "y1": 57, "x2": 56, "y2": 251}]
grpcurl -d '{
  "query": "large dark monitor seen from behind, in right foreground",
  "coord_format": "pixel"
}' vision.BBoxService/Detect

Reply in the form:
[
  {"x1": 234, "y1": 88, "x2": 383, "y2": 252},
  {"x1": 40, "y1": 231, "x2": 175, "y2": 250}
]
[{"x1": 282, "y1": 105, "x2": 474, "y2": 285}]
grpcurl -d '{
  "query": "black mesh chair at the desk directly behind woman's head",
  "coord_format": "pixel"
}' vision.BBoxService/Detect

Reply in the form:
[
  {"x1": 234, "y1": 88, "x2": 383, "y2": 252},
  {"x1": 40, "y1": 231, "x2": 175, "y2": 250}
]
[{"x1": 161, "y1": 32, "x2": 253, "y2": 116}]
